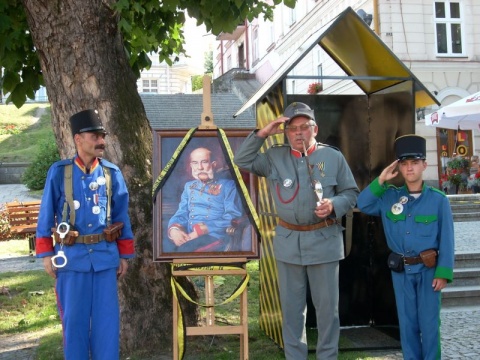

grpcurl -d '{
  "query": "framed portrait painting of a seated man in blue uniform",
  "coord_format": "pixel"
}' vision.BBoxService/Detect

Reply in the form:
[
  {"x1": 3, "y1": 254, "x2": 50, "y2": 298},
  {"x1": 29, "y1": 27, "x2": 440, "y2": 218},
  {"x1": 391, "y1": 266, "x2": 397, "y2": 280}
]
[{"x1": 152, "y1": 129, "x2": 260, "y2": 262}]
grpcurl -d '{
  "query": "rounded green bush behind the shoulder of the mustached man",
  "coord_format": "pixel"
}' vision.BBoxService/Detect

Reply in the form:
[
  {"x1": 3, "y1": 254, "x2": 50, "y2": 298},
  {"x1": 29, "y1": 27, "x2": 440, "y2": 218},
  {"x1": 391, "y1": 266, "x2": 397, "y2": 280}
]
[{"x1": 22, "y1": 137, "x2": 60, "y2": 190}]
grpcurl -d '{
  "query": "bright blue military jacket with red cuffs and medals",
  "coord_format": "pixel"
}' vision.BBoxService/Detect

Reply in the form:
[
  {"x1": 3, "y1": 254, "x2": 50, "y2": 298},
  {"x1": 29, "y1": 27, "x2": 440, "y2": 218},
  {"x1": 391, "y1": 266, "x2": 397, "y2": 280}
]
[{"x1": 36, "y1": 157, "x2": 134, "y2": 271}]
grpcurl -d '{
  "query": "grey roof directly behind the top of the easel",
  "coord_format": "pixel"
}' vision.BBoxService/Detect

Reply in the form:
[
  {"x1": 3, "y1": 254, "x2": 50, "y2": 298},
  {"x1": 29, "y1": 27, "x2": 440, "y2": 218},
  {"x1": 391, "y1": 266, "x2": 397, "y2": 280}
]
[{"x1": 140, "y1": 93, "x2": 256, "y2": 130}]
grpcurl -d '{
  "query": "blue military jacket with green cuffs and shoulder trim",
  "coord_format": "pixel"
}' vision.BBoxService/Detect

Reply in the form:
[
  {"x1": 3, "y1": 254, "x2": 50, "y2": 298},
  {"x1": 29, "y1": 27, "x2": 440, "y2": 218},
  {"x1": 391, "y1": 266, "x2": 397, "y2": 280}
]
[{"x1": 357, "y1": 178, "x2": 455, "y2": 282}]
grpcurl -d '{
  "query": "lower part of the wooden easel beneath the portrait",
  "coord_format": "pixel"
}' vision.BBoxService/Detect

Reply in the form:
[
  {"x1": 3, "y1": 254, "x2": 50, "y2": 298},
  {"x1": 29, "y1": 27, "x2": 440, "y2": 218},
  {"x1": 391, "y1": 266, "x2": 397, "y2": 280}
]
[{"x1": 172, "y1": 258, "x2": 248, "y2": 360}]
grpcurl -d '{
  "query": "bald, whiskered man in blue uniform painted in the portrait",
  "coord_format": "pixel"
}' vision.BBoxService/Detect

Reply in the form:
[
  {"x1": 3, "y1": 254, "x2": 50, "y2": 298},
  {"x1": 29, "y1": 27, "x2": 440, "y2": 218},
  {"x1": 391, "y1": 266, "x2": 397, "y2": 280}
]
[{"x1": 168, "y1": 147, "x2": 242, "y2": 252}]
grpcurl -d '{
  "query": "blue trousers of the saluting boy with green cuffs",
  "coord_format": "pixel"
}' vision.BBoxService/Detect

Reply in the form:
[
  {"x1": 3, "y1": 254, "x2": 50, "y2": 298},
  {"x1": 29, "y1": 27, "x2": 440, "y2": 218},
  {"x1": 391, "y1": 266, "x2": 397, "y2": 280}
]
[{"x1": 392, "y1": 268, "x2": 441, "y2": 360}]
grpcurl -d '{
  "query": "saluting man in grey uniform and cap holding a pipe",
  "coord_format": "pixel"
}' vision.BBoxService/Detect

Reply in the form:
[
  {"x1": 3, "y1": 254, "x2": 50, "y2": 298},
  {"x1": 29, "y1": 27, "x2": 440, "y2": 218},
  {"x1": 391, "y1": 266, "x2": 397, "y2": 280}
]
[{"x1": 235, "y1": 102, "x2": 359, "y2": 360}]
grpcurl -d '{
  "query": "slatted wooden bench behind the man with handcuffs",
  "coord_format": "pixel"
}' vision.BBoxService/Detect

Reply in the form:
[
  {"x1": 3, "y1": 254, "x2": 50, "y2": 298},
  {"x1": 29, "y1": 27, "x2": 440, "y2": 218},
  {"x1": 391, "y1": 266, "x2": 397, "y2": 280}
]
[{"x1": 6, "y1": 200, "x2": 40, "y2": 255}]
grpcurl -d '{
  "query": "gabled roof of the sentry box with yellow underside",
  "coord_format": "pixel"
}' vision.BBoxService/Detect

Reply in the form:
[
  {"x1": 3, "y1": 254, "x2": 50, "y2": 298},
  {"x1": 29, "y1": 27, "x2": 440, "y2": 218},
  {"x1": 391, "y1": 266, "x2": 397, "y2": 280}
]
[{"x1": 234, "y1": 7, "x2": 440, "y2": 117}]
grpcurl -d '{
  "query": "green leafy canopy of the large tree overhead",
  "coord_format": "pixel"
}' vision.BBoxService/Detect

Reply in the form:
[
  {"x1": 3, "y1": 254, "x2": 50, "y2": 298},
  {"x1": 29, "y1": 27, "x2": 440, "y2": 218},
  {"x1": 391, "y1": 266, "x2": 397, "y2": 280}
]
[{"x1": 0, "y1": 0, "x2": 296, "y2": 107}]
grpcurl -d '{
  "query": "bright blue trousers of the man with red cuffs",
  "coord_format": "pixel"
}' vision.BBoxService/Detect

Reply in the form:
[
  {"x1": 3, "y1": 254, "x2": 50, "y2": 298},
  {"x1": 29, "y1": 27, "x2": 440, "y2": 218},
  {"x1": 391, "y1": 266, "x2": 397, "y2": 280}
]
[{"x1": 55, "y1": 268, "x2": 120, "y2": 360}]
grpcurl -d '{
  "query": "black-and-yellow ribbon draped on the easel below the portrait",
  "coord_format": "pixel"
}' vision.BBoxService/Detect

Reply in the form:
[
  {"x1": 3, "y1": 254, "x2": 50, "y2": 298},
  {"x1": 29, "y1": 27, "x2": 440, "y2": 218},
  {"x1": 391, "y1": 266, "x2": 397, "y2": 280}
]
[{"x1": 170, "y1": 264, "x2": 250, "y2": 360}]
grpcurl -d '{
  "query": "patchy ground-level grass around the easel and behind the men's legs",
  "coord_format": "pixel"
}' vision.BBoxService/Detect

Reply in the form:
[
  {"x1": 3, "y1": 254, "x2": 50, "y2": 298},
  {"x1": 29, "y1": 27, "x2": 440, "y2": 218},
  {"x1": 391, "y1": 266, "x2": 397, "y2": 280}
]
[{"x1": 0, "y1": 240, "x2": 382, "y2": 360}]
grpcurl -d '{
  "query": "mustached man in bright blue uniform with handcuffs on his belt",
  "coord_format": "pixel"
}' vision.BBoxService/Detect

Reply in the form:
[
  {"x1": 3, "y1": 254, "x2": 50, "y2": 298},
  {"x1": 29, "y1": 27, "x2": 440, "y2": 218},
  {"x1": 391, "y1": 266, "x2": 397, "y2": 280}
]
[{"x1": 36, "y1": 110, "x2": 134, "y2": 360}]
